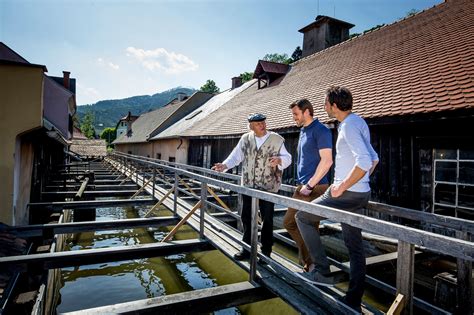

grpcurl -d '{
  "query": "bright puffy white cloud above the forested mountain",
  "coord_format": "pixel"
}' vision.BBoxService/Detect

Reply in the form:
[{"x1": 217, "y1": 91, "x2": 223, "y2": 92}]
[{"x1": 126, "y1": 47, "x2": 199, "y2": 74}]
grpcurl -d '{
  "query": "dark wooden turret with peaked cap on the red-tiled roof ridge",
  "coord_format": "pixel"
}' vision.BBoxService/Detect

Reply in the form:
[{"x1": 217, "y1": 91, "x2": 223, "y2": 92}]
[{"x1": 298, "y1": 15, "x2": 354, "y2": 57}]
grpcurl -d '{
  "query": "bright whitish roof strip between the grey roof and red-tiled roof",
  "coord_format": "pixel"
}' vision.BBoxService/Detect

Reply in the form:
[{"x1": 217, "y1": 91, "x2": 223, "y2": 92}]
[{"x1": 152, "y1": 79, "x2": 257, "y2": 140}]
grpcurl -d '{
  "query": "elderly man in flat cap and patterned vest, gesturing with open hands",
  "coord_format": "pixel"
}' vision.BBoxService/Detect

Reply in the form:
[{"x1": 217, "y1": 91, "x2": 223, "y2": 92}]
[{"x1": 212, "y1": 114, "x2": 291, "y2": 260}]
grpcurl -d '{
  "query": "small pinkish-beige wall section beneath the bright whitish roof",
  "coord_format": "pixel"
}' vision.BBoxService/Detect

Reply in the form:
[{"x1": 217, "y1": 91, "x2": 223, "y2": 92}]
[{"x1": 152, "y1": 139, "x2": 189, "y2": 164}]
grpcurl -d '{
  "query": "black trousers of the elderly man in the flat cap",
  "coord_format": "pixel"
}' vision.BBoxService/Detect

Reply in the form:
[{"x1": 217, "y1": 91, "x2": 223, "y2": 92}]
[{"x1": 241, "y1": 195, "x2": 275, "y2": 256}]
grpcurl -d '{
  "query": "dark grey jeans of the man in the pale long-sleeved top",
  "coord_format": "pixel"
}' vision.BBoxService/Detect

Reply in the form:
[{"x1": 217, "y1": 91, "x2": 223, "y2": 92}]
[{"x1": 296, "y1": 187, "x2": 370, "y2": 305}]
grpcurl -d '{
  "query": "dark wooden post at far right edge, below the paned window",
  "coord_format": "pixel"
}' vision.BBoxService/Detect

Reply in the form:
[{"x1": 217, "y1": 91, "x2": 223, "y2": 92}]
[{"x1": 456, "y1": 231, "x2": 474, "y2": 314}]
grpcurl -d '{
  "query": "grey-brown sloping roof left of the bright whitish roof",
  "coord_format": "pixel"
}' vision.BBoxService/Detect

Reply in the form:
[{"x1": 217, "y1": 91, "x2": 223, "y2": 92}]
[{"x1": 113, "y1": 92, "x2": 212, "y2": 144}]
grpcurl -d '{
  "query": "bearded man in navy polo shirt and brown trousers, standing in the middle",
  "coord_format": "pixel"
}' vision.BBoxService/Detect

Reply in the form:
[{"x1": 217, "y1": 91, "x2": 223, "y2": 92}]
[{"x1": 283, "y1": 99, "x2": 332, "y2": 271}]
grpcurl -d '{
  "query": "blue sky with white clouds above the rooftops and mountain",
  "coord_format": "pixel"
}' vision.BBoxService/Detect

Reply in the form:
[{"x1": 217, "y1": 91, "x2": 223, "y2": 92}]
[{"x1": 0, "y1": 0, "x2": 443, "y2": 105}]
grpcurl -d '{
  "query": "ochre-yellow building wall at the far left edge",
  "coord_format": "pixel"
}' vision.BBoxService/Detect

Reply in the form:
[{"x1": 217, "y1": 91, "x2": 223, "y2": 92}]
[{"x1": 0, "y1": 65, "x2": 43, "y2": 224}]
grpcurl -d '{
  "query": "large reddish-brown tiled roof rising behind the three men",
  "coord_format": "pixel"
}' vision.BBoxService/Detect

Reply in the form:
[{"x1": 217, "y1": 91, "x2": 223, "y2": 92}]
[{"x1": 185, "y1": 0, "x2": 474, "y2": 136}]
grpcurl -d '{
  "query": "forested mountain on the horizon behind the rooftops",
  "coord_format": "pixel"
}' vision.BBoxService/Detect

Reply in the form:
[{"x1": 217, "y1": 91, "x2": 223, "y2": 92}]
[{"x1": 77, "y1": 87, "x2": 196, "y2": 134}]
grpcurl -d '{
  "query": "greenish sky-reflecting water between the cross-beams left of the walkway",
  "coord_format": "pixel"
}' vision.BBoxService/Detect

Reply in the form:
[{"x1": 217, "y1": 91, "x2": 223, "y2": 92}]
[{"x1": 57, "y1": 207, "x2": 295, "y2": 314}]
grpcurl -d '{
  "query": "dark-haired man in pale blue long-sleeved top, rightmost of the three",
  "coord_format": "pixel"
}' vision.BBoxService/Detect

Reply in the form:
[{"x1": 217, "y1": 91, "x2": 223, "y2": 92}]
[{"x1": 296, "y1": 86, "x2": 378, "y2": 312}]
